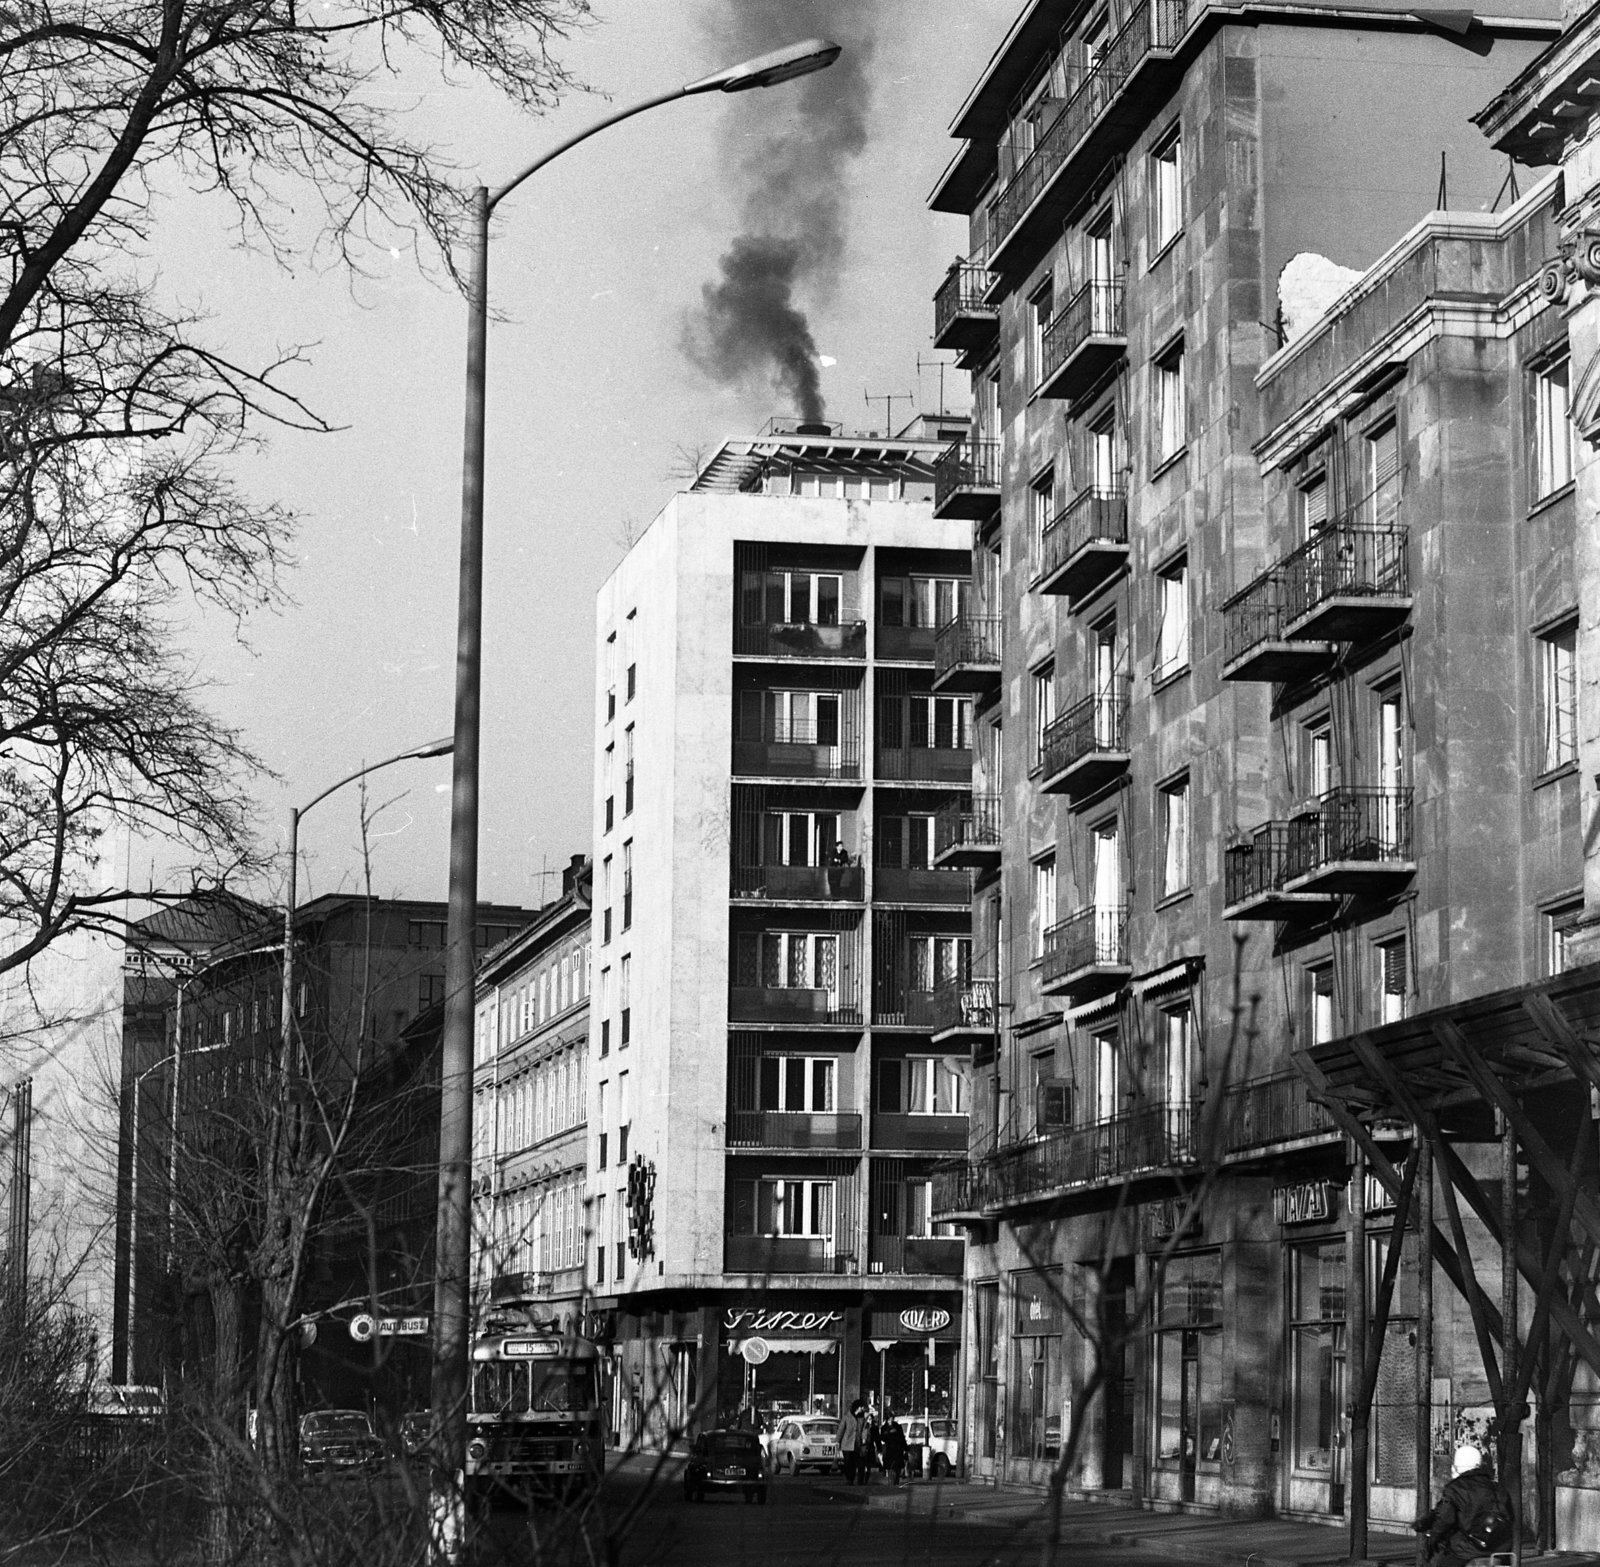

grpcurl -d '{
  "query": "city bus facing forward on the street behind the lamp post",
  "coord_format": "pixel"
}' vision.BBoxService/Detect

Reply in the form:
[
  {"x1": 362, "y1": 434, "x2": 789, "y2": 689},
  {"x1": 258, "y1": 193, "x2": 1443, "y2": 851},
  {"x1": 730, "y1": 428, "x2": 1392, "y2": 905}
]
[{"x1": 466, "y1": 1324, "x2": 605, "y2": 1503}]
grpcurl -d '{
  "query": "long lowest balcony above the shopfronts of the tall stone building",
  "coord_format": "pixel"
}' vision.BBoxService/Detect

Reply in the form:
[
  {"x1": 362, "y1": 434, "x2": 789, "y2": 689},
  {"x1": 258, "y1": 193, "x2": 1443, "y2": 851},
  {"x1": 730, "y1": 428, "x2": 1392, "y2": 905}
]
[{"x1": 979, "y1": 1104, "x2": 1195, "y2": 1212}]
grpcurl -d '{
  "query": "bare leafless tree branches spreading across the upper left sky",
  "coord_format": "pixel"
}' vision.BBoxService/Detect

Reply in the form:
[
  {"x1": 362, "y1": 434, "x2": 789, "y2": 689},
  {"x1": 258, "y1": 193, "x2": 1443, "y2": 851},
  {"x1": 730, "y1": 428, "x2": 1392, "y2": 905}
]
[{"x1": 0, "y1": 0, "x2": 589, "y2": 970}]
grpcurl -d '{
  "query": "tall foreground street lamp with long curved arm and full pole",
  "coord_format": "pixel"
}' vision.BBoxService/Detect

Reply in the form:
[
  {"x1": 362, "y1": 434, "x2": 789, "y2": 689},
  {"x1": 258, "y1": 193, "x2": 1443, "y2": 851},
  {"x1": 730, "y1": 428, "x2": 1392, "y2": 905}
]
[{"x1": 432, "y1": 38, "x2": 840, "y2": 1556}]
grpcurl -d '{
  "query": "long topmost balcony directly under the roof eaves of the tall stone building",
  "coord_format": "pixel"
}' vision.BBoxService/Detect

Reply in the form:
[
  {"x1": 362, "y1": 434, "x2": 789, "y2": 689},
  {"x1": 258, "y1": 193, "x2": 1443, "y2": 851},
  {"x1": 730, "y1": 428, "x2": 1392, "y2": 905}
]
[{"x1": 989, "y1": 0, "x2": 1189, "y2": 274}]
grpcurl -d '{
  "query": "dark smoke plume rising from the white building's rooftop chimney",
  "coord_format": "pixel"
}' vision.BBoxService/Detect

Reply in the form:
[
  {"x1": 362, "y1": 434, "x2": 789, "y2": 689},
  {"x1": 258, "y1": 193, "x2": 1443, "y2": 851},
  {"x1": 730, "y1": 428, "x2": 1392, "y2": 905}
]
[{"x1": 683, "y1": 0, "x2": 874, "y2": 419}]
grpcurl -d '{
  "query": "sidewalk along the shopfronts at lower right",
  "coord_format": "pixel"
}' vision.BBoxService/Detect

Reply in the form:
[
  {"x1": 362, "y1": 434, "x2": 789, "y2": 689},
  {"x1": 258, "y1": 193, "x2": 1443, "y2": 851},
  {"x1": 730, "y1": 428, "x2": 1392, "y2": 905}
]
[{"x1": 816, "y1": 1481, "x2": 1600, "y2": 1567}]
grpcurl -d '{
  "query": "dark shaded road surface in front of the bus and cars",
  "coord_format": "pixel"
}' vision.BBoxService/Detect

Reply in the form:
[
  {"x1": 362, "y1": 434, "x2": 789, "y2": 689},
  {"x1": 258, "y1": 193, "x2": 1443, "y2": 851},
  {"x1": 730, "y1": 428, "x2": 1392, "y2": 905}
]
[{"x1": 477, "y1": 1465, "x2": 1150, "y2": 1567}]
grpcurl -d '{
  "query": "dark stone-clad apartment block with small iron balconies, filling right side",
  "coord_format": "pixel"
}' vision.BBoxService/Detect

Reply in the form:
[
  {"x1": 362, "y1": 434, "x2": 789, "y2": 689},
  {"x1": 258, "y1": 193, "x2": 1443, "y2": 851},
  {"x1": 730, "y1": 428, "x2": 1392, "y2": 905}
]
[{"x1": 933, "y1": 0, "x2": 1600, "y2": 1548}]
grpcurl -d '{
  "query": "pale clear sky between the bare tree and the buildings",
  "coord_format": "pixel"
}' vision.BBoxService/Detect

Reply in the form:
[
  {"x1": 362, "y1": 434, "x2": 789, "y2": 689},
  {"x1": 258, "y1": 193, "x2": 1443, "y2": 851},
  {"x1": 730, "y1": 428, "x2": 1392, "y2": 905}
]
[{"x1": 152, "y1": 0, "x2": 1018, "y2": 904}]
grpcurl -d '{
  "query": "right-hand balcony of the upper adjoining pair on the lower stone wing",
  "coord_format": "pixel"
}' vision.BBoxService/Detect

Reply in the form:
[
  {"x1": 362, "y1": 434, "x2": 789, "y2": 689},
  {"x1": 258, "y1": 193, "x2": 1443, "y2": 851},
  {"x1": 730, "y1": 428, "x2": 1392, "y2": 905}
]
[{"x1": 1283, "y1": 525, "x2": 1411, "y2": 642}]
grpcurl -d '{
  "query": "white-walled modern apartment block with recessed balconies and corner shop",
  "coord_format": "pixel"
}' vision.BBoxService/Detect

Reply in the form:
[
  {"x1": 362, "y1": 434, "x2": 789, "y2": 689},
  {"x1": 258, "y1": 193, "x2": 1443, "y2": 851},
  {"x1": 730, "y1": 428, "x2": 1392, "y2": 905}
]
[{"x1": 589, "y1": 419, "x2": 979, "y2": 1444}]
